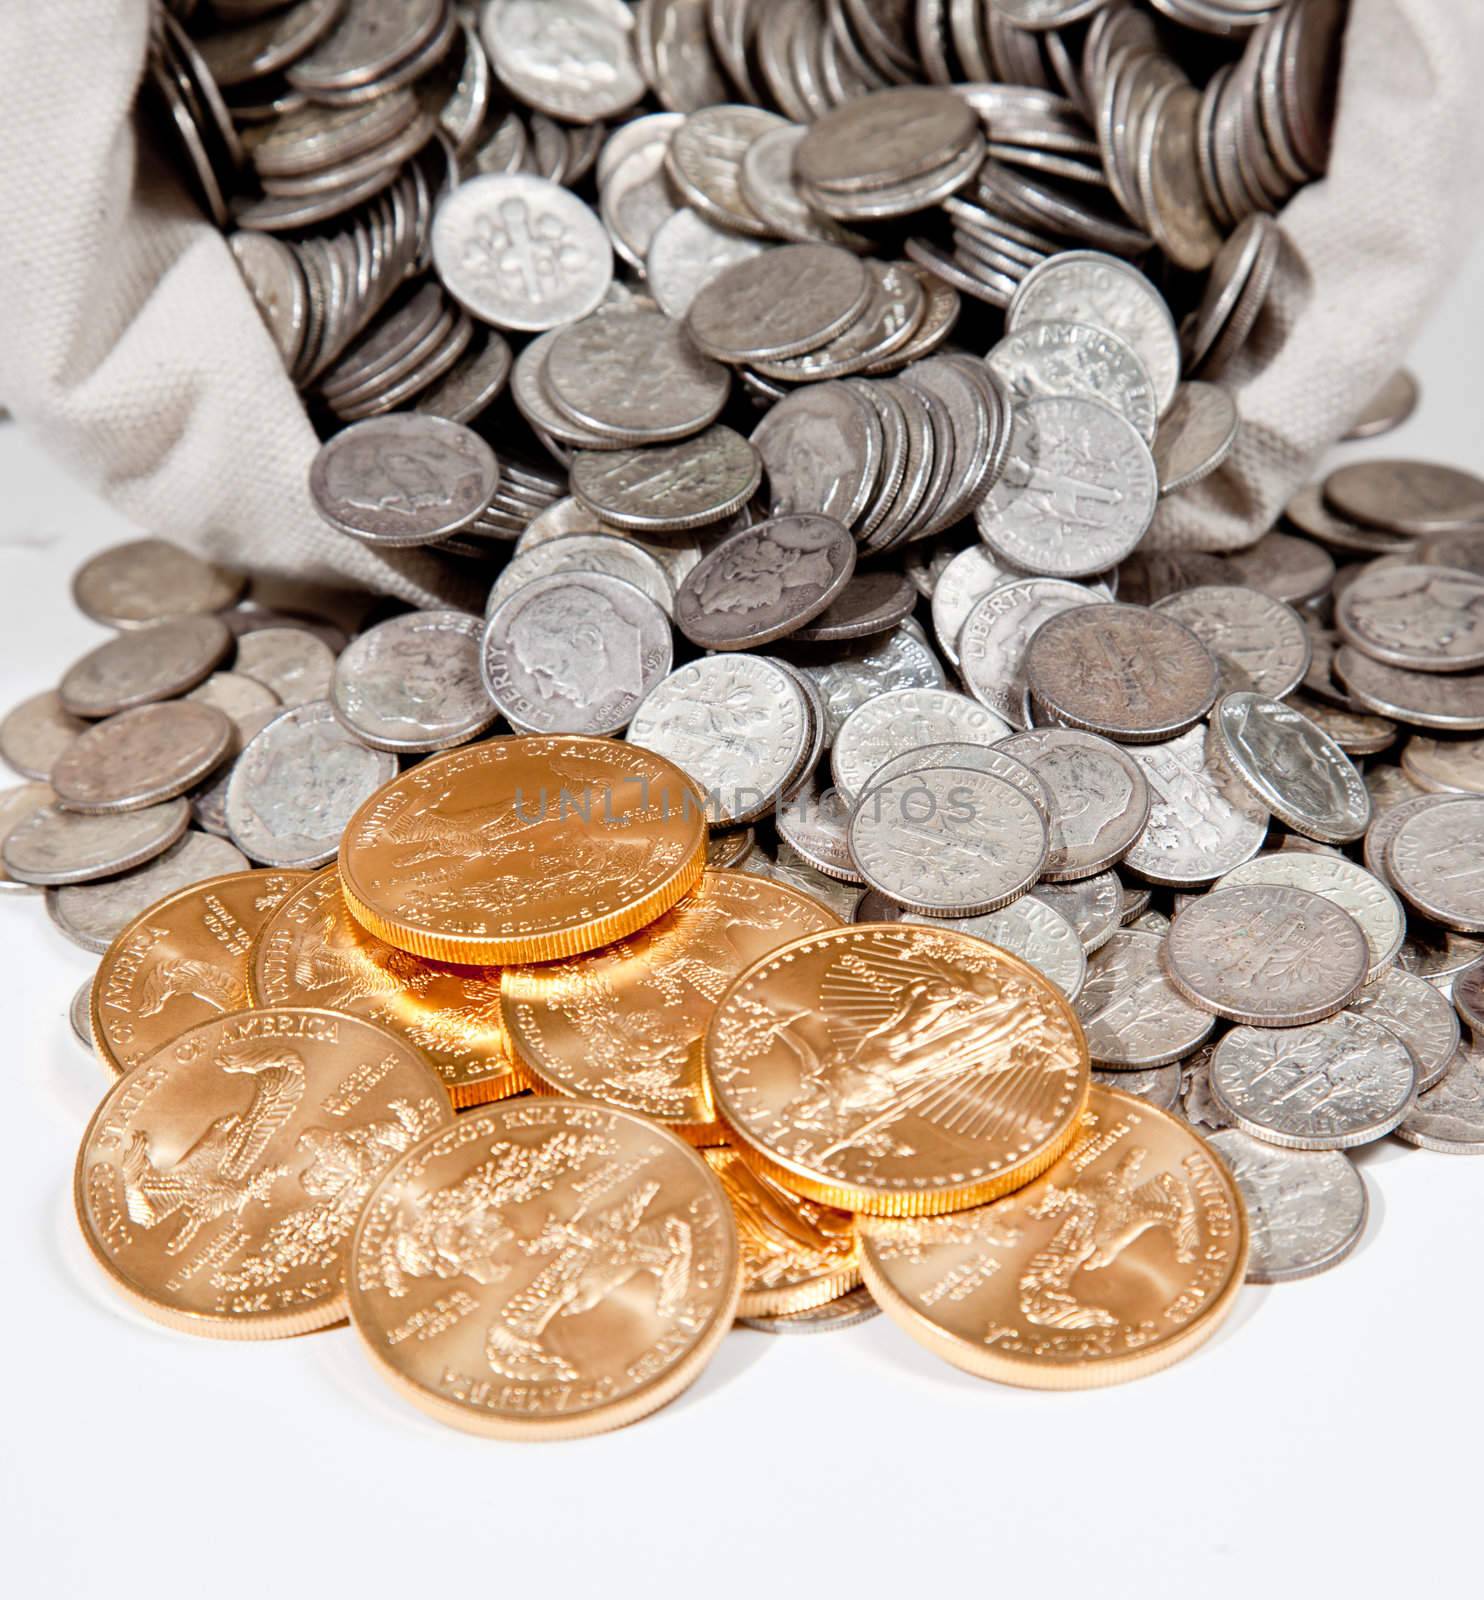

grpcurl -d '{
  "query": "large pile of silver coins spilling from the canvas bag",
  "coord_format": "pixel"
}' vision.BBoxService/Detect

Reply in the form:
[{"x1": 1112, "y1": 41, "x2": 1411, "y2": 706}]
[{"x1": 0, "y1": 0, "x2": 1484, "y2": 1299}]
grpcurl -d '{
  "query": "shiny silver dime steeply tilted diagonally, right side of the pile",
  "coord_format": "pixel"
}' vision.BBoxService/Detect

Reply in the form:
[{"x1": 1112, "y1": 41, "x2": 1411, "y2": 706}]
[{"x1": 1211, "y1": 691, "x2": 1370, "y2": 845}]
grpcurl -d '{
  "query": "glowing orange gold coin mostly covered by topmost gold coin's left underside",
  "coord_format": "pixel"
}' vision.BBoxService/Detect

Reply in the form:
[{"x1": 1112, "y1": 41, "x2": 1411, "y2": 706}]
[{"x1": 248, "y1": 867, "x2": 531, "y2": 1107}]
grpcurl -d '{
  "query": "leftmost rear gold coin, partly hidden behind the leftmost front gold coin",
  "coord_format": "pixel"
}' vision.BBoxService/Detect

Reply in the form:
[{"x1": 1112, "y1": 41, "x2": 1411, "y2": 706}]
[{"x1": 88, "y1": 872, "x2": 309, "y2": 1072}]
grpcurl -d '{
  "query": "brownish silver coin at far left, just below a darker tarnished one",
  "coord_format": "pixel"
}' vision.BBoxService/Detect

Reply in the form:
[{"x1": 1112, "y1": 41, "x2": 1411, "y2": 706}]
[{"x1": 51, "y1": 701, "x2": 237, "y2": 814}]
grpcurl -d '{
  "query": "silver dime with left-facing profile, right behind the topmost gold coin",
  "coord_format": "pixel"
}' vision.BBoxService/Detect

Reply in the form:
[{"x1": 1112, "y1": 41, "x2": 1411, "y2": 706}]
[{"x1": 478, "y1": 573, "x2": 673, "y2": 734}]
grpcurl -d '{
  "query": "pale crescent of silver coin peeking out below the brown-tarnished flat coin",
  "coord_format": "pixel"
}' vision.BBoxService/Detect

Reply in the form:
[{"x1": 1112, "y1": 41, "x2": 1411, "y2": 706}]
[{"x1": 999, "y1": 728, "x2": 1150, "y2": 880}]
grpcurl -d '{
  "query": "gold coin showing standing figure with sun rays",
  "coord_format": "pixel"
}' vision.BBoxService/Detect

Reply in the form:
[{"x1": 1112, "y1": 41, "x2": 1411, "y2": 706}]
[{"x1": 705, "y1": 923, "x2": 1089, "y2": 1216}]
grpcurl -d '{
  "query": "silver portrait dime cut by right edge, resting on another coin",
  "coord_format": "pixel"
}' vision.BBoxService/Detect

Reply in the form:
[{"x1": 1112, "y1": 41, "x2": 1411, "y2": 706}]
[{"x1": 1335, "y1": 563, "x2": 1484, "y2": 672}]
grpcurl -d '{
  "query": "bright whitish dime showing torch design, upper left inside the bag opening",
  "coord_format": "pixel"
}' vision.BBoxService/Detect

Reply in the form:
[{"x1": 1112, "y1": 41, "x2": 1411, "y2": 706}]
[{"x1": 430, "y1": 173, "x2": 612, "y2": 333}]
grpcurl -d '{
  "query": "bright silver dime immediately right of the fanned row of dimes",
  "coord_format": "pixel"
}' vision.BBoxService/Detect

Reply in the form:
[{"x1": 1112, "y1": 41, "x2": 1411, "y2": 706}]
[{"x1": 974, "y1": 397, "x2": 1159, "y2": 578}]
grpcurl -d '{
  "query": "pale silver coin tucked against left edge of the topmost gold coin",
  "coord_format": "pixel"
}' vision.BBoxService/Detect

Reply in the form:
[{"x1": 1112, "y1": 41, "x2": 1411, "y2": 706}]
[{"x1": 227, "y1": 701, "x2": 397, "y2": 867}]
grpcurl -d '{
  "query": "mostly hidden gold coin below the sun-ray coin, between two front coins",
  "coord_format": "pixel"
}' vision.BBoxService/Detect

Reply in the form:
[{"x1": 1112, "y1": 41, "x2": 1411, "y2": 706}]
[{"x1": 700, "y1": 1147, "x2": 860, "y2": 1317}]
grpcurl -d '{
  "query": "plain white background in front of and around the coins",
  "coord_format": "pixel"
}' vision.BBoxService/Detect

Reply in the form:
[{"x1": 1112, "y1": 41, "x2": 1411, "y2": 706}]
[{"x1": 0, "y1": 240, "x2": 1484, "y2": 1600}]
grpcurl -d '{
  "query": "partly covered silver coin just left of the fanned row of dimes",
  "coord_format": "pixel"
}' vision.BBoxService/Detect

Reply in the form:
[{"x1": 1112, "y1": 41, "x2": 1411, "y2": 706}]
[{"x1": 571, "y1": 426, "x2": 763, "y2": 533}]
